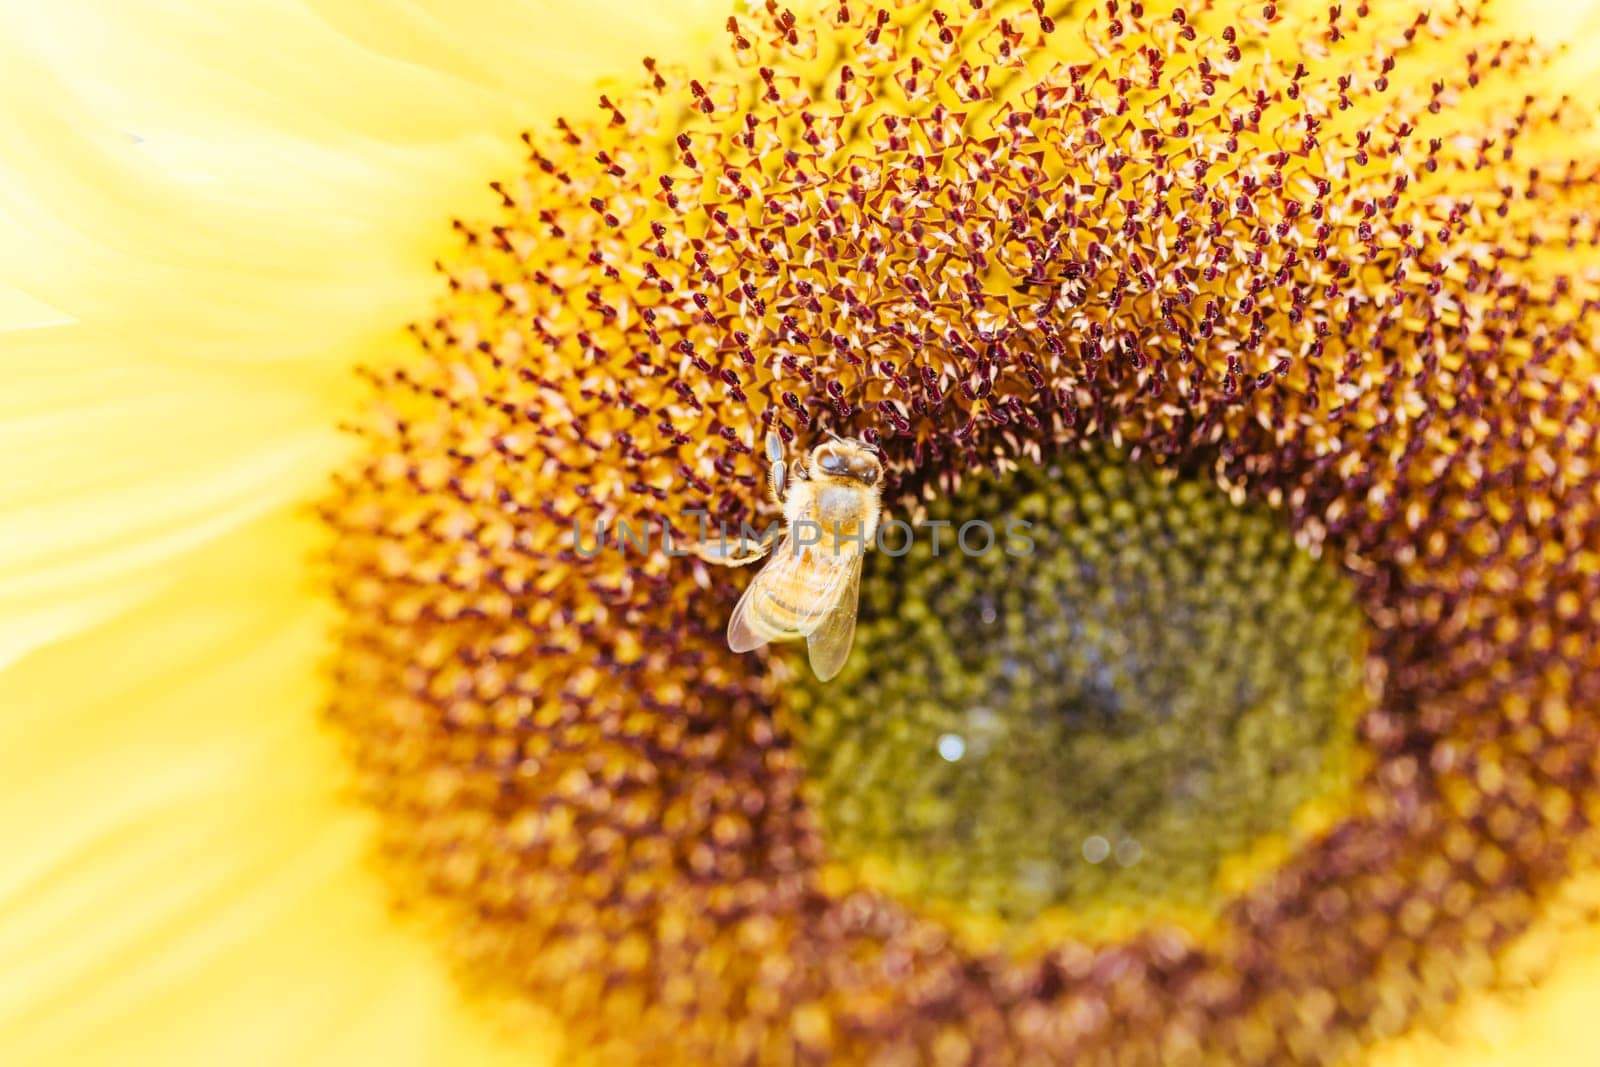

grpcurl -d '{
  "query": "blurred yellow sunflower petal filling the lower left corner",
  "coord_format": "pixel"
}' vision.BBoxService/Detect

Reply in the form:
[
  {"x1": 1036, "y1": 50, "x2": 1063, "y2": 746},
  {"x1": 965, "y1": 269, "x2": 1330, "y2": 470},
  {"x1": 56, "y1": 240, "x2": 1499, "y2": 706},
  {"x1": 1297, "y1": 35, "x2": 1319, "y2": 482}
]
[{"x1": 0, "y1": 517, "x2": 549, "y2": 1064}]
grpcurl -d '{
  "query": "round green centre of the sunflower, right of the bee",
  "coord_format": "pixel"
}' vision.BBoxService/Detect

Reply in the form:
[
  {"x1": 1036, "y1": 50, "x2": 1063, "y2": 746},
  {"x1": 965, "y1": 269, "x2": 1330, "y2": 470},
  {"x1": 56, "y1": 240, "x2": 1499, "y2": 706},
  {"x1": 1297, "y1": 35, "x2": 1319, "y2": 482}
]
[{"x1": 792, "y1": 453, "x2": 1370, "y2": 933}]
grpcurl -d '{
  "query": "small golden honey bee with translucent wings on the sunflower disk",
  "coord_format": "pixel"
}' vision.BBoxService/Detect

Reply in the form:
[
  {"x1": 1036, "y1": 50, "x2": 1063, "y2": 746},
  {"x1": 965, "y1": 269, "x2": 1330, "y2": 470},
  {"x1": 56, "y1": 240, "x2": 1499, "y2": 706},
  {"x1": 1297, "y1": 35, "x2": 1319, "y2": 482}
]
[{"x1": 701, "y1": 434, "x2": 883, "y2": 681}]
